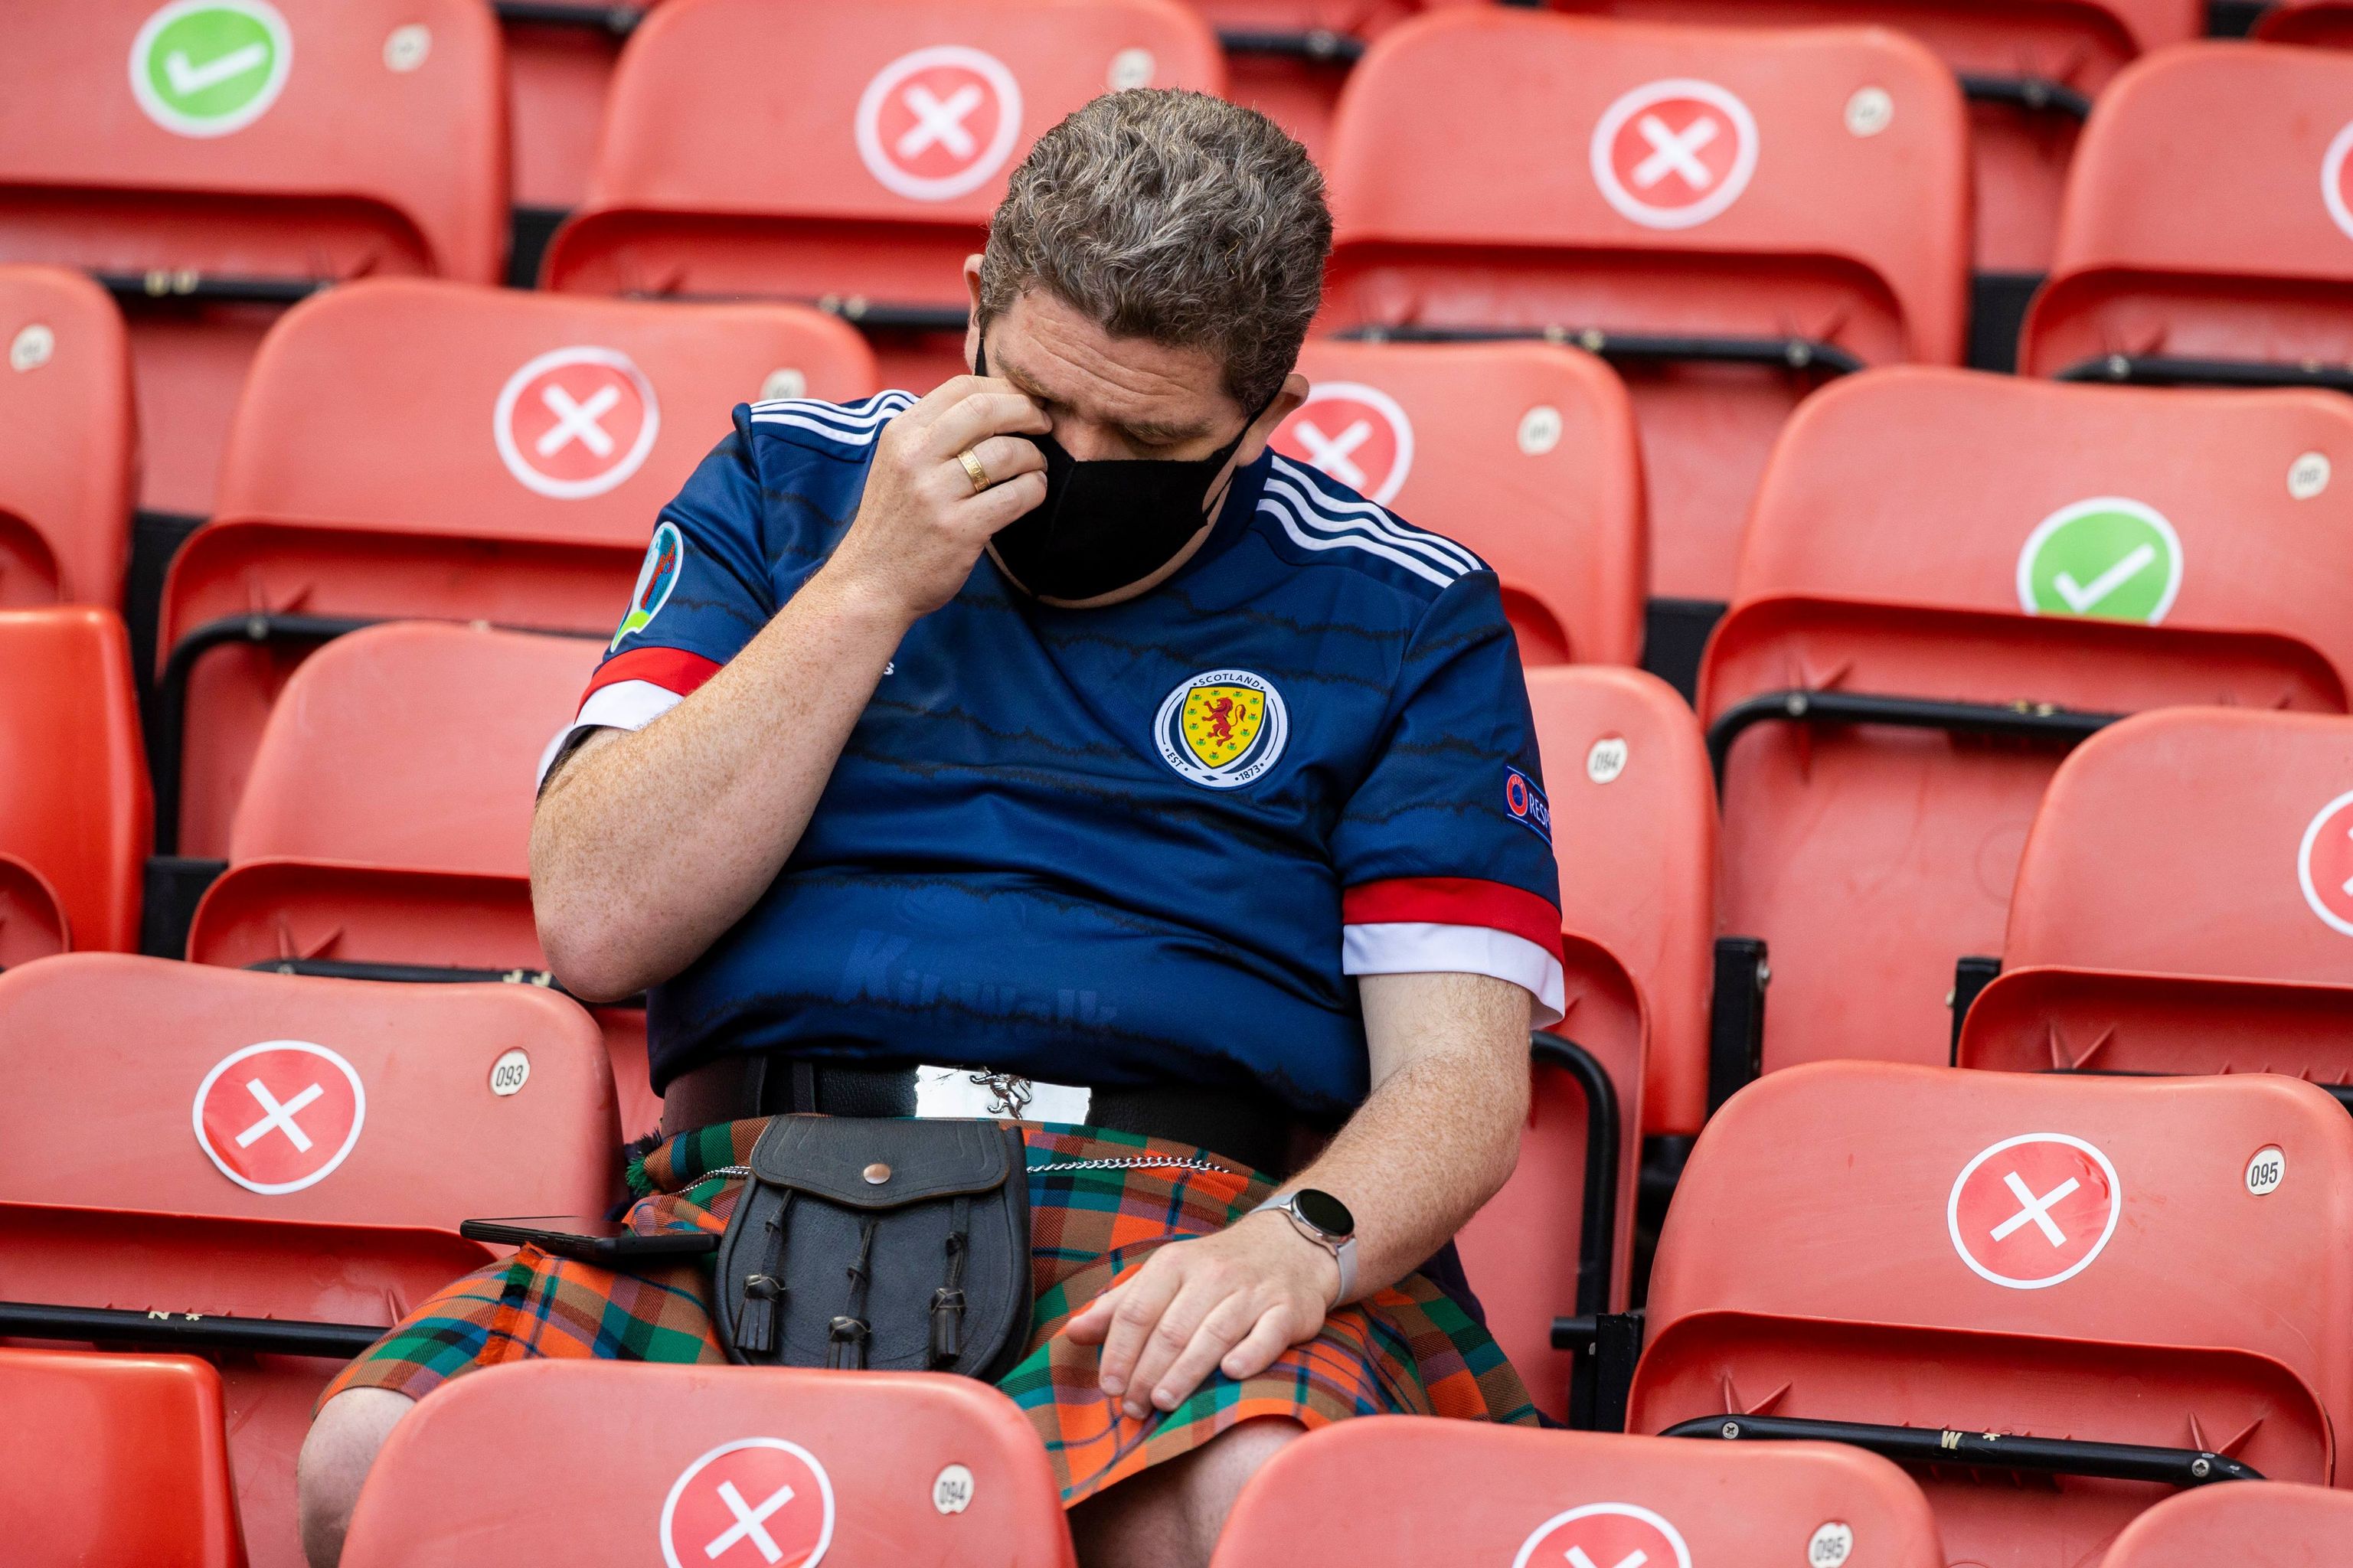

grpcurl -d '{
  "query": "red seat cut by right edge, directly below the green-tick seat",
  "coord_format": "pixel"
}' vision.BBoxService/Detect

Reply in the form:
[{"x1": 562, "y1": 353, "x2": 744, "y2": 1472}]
[{"x1": 1956, "y1": 709, "x2": 2353, "y2": 1099}]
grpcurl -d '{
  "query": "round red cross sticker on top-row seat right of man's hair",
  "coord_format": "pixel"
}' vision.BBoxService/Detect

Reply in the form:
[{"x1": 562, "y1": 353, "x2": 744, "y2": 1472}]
[{"x1": 1590, "y1": 77, "x2": 1758, "y2": 228}]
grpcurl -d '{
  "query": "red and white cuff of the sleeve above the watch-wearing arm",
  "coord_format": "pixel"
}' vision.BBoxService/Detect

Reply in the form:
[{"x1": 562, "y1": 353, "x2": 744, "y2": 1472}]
[{"x1": 1339, "y1": 876, "x2": 1565, "y2": 1029}]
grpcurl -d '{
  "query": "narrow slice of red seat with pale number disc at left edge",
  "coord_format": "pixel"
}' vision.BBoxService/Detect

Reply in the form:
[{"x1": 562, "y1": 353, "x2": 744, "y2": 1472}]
[{"x1": 0, "y1": 266, "x2": 139, "y2": 609}]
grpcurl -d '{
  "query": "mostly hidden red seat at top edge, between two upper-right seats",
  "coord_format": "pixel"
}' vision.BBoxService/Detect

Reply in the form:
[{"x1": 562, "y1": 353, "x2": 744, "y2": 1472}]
[{"x1": 1551, "y1": 0, "x2": 2204, "y2": 273}]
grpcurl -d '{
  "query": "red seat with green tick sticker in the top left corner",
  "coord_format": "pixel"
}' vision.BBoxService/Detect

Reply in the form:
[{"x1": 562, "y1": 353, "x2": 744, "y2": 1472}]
[{"x1": 0, "y1": 0, "x2": 506, "y2": 513}]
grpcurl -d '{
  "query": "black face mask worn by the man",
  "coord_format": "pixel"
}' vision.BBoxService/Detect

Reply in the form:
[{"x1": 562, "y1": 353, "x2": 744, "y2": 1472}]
[{"x1": 974, "y1": 344, "x2": 1273, "y2": 603}]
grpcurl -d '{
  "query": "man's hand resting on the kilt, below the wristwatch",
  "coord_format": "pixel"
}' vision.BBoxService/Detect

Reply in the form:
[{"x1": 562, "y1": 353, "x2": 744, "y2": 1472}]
[{"x1": 1064, "y1": 1210, "x2": 1339, "y2": 1417}]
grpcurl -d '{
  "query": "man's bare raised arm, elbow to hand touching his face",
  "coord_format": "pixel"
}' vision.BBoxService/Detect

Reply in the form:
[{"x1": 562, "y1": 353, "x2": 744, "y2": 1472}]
[{"x1": 531, "y1": 377, "x2": 1052, "y2": 1001}]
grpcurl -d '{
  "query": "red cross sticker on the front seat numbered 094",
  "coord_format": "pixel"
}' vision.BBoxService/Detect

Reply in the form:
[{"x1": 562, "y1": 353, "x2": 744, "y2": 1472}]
[{"x1": 662, "y1": 1439, "x2": 833, "y2": 1568}]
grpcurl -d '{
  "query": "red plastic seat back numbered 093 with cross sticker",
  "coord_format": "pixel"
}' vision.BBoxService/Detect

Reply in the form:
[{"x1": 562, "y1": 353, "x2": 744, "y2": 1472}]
[{"x1": 0, "y1": 953, "x2": 616, "y2": 1229}]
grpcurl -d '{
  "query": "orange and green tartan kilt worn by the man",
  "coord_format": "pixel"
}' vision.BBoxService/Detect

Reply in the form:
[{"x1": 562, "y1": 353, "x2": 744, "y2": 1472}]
[{"x1": 320, "y1": 1121, "x2": 1537, "y2": 1507}]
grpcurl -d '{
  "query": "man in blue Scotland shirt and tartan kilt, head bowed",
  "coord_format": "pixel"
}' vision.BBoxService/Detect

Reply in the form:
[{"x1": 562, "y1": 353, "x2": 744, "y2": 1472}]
[{"x1": 301, "y1": 90, "x2": 1562, "y2": 1568}]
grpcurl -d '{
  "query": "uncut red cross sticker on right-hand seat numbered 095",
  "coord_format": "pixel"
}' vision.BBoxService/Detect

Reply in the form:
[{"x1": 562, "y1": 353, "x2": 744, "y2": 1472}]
[{"x1": 1946, "y1": 1132, "x2": 2123, "y2": 1290}]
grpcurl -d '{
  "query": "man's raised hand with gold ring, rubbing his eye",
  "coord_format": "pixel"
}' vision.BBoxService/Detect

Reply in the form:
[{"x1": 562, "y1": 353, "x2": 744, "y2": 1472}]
[{"x1": 826, "y1": 377, "x2": 1054, "y2": 624}]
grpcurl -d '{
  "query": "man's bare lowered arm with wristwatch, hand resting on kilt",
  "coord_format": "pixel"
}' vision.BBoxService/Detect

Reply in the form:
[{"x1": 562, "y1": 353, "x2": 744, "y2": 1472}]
[{"x1": 1068, "y1": 975, "x2": 1532, "y2": 1415}]
